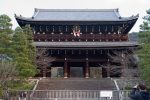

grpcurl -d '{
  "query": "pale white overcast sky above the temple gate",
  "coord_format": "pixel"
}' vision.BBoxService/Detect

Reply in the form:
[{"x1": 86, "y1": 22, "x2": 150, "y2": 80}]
[{"x1": 0, "y1": 0, "x2": 150, "y2": 32}]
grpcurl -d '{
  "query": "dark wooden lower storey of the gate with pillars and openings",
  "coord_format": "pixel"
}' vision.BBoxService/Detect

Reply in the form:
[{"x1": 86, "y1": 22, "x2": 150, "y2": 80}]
[{"x1": 37, "y1": 48, "x2": 133, "y2": 78}]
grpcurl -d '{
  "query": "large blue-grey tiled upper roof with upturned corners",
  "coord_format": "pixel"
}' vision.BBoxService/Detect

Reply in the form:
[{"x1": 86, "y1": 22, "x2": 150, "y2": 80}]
[{"x1": 16, "y1": 8, "x2": 138, "y2": 21}]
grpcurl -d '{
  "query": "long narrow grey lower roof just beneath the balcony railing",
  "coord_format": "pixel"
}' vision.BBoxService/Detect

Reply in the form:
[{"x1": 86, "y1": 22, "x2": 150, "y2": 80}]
[{"x1": 34, "y1": 42, "x2": 138, "y2": 48}]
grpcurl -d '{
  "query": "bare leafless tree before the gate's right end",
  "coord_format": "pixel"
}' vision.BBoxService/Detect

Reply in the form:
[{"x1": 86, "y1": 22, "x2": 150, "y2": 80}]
[{"x1": 108, "y1": 50, "x2": 139, "y2": 89}]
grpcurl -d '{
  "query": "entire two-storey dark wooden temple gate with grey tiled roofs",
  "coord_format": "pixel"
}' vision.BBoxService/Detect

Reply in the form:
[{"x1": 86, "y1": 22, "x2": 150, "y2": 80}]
[{"x1": 15, "y1": 8, "x2": 139, "y2": 78}]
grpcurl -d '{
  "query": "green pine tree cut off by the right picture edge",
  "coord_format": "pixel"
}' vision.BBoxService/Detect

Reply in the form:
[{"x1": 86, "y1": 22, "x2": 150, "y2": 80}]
[{"x1": 138, "y1": 9, "x2": 150, "y2": 86}]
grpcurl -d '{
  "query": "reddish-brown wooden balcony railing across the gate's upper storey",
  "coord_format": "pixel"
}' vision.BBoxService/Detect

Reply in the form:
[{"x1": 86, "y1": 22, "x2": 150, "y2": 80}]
[{"x1": 34, "y1": 34, "x2": 128, "y2": 42}]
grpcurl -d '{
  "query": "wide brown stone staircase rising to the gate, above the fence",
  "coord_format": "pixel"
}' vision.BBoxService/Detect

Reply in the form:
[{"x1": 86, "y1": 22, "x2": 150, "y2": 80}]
[{"x1": 36, "y1": 78, "x2": 116, "y2": 90}]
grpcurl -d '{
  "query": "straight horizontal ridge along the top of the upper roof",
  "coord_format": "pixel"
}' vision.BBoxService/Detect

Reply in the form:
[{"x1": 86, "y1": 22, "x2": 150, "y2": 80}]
[{"x1": 35, "y1": 8, "x2": 118, "y2": 12}]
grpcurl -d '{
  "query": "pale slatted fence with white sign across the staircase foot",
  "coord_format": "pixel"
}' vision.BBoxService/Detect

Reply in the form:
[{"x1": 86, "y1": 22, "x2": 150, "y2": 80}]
[{"x1": 5, "y1": 90, "x2": 130, "y2": 100}]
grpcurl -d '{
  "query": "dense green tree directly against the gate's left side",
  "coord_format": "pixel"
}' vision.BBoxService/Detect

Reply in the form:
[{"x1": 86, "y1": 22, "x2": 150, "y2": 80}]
[{"x1": 13, "y1": 26, "x2": 37, "y2": 77}]
